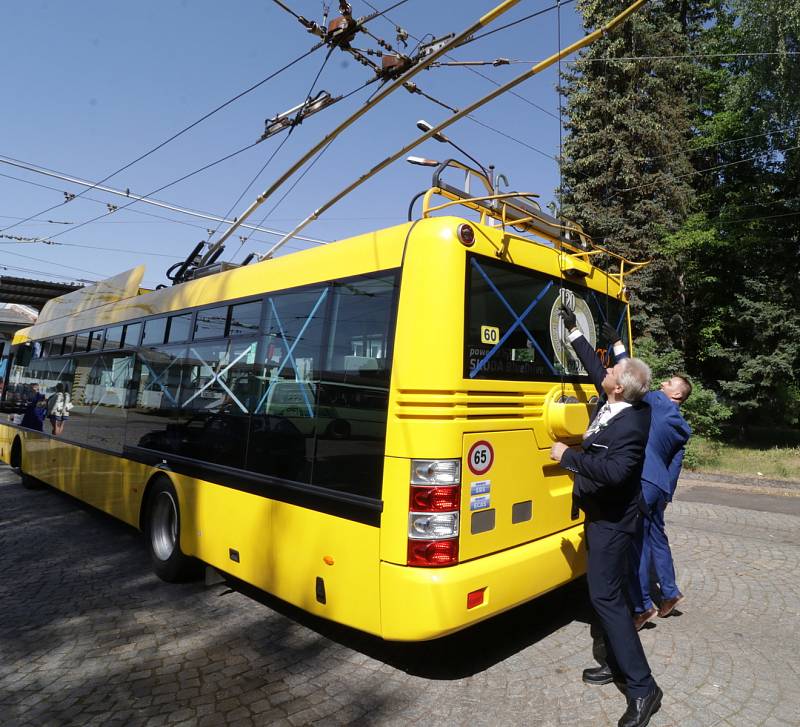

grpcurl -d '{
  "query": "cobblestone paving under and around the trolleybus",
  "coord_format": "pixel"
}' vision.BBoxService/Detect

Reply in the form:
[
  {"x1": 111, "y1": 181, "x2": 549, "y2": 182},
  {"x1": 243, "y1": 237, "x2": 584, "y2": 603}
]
[{"x1": 0, "y1": 467, "x2": 800, "y2": 727}]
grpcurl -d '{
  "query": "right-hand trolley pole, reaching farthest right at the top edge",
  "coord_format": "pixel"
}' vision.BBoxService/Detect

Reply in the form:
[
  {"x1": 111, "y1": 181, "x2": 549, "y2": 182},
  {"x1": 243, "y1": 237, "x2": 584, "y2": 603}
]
[{"x1": 259, "y1": 0, "x2": 647, "y2": 260}]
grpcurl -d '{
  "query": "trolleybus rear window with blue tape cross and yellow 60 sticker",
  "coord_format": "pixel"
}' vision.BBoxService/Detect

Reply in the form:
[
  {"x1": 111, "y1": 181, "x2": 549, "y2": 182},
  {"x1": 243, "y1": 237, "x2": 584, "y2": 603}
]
[{"x1": 464, "y1": 255, "x2": 628, "y2": 381}]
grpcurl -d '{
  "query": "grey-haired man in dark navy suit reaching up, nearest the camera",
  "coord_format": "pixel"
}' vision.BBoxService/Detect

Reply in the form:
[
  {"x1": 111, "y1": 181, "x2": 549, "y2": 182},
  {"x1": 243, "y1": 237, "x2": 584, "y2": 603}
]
[{"x1": 550, "y1": 307, "x2": 663, "y2": 727}]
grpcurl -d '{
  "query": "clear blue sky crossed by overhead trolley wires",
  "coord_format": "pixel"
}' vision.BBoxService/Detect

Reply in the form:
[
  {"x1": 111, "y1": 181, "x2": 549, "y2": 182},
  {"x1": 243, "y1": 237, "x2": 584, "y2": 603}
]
[{"x1": 0, "y1": 0, "x2": 584, "y2": 285}]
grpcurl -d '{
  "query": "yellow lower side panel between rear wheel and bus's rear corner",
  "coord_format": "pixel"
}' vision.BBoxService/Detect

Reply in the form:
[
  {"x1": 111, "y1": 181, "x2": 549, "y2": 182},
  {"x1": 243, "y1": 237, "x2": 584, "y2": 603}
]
[{"x1": 179, "y1": 474, "x2": 380, "y2": 635}]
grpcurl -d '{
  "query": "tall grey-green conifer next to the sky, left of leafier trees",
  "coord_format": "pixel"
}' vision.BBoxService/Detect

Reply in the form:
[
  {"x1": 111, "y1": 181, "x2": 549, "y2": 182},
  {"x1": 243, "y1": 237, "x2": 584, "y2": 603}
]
[{"x1": 561, "y1": 0, "x2": 695, "y2": 348}]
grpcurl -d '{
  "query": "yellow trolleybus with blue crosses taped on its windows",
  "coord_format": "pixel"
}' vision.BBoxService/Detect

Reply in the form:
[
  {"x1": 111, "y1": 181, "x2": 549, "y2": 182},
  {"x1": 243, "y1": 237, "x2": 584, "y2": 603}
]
[{"x1": 0, "y1": 161, "x2": 630, "y2": 640}]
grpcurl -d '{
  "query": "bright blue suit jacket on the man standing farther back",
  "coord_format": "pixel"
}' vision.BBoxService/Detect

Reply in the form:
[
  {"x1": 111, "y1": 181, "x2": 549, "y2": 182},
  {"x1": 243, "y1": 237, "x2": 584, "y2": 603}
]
[{"x1": 617, "y1": 352, "x2": 692, "y2": 502}]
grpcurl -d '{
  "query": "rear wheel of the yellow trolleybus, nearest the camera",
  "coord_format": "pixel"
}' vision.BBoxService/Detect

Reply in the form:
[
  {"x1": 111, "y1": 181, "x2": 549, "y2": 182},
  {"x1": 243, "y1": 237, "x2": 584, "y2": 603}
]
[{"x1": 145, "y1": 479, "x2": 200, "y2": 583}]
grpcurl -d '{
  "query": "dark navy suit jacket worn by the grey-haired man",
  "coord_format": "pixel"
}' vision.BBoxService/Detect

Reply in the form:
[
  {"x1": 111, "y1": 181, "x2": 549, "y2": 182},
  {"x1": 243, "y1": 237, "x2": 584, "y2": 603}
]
[{"x1": 561, "y1": 336, "x2": 650, "y2": 533}]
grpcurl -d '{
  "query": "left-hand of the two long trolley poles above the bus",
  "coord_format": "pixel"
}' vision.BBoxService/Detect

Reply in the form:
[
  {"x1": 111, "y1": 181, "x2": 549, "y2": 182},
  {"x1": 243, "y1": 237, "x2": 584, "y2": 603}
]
[{"x1": 201, "y1": 0, "x2": 524, "y2": 265}]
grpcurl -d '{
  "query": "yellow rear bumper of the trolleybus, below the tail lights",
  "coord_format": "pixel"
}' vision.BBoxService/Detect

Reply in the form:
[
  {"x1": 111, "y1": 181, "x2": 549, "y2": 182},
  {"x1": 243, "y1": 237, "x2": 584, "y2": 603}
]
[{"x1": 381, "y1": 524, "x2": 586, "y2": 641}]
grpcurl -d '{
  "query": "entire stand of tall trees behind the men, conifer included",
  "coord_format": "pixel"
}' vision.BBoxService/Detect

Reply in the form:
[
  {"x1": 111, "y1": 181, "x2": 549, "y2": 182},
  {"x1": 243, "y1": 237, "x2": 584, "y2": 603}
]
[{"x1": 562, "y1": 0, "x2": 800, "y2": 433}]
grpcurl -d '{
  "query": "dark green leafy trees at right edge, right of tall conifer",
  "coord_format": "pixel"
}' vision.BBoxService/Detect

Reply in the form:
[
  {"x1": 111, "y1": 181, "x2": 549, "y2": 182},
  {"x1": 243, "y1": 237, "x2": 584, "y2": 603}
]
[{"x1": 659, "y1": 0, "x2": 800, "y2": 432}]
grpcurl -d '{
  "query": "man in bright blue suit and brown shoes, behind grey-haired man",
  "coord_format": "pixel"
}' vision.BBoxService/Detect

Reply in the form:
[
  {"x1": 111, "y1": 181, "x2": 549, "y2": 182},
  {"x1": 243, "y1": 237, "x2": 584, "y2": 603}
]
[{"x1": 604, "y1": 326, "x2": 692, "y2": 631}]
